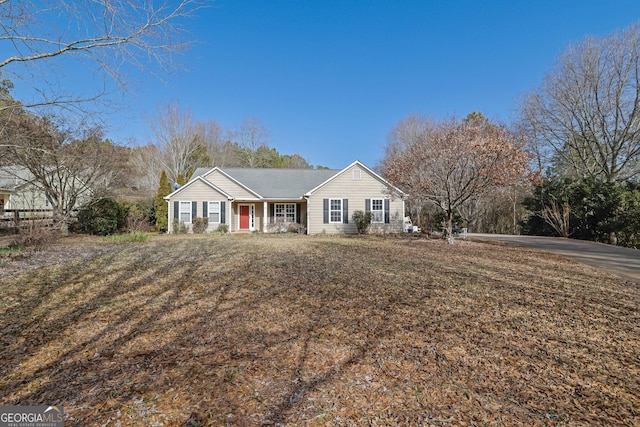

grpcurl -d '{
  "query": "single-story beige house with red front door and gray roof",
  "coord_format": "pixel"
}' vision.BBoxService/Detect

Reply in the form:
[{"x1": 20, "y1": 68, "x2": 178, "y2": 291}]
[{"x1": 165, "y1": 161, "x2": 405, "y2": 234}]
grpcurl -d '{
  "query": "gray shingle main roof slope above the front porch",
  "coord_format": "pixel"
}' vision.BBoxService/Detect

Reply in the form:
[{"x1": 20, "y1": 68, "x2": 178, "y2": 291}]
[{"x1": 192, "y1": 168, "x2": 339, "y2": 199}]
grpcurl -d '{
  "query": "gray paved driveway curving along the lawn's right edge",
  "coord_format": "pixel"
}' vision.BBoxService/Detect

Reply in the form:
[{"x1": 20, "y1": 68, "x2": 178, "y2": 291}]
[{"x1": 467, "y1": 233, "x2": 640, "y2": 283}]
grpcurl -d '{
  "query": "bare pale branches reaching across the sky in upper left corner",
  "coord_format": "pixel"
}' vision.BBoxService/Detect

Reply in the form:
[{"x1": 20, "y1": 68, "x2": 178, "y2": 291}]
[{"x1": 0, "y1": 0, "x2": 208, "y2": 112}]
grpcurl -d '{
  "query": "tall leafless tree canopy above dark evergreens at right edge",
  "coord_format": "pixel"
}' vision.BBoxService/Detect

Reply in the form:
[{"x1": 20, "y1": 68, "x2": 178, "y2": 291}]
[{"x1": 522, "y1": 25, "x2": 640, "y2": 181}]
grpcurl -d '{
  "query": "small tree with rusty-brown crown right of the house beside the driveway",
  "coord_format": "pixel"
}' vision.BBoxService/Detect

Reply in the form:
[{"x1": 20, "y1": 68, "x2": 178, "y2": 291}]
[{"x1": 381, "y1": 114, "x2": 529, "y2": 242}]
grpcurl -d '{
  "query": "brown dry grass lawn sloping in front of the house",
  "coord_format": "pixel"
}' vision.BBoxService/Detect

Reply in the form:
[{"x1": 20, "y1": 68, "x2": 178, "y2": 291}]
[{"x1": 0, "y1": 236, "x2": 640, "y2": 426}]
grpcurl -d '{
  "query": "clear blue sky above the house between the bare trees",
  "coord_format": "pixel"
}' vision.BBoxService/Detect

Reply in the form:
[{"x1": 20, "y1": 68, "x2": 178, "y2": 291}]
[{"x1": 10, "y1": 0, "x2": 640, "y2": 168}]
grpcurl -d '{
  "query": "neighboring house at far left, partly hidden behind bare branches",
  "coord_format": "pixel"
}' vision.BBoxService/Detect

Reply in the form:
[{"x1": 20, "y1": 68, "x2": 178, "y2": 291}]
[{"x1": 0, "y1": 166, "x2": 52, "y2": 217}]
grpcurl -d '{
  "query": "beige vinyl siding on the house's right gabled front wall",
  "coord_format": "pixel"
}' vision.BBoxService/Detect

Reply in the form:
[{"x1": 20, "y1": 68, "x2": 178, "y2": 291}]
[{"x1": 307, "y1": 164, "x2": 404, "y2": 234}]
